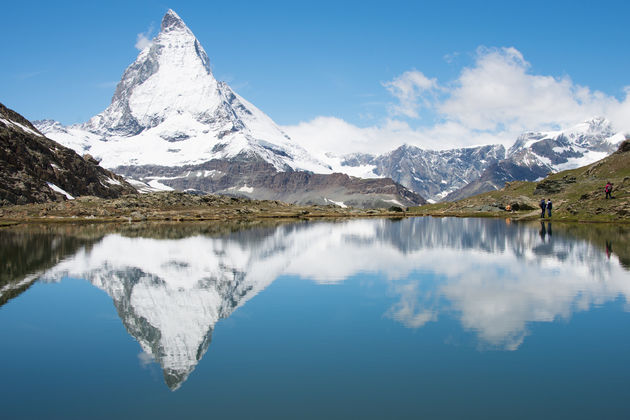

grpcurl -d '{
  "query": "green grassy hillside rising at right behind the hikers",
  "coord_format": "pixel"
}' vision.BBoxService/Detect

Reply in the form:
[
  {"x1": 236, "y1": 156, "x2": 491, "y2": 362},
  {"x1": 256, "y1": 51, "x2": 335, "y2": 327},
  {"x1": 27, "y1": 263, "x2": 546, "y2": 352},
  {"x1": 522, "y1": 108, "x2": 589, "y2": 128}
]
[{"x1": 410, "y1": 140, "x2": 630, "y2": 222}]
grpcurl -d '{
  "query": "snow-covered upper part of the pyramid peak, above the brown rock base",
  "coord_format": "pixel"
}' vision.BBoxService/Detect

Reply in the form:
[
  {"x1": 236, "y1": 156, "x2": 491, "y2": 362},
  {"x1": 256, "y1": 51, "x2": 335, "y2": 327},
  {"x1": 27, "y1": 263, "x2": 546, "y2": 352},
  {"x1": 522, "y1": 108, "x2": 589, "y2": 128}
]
[{"x1": 37, "y1": 10, "x2": 330, "y2": 173}]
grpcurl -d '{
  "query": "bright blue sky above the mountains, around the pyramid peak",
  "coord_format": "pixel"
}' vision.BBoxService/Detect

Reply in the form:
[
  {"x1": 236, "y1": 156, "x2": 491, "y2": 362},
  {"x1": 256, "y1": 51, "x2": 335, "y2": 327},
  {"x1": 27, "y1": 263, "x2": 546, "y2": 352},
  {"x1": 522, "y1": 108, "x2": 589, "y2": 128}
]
[{"x1": 0, "y1": 1, "x2": 630, "y2": 151}]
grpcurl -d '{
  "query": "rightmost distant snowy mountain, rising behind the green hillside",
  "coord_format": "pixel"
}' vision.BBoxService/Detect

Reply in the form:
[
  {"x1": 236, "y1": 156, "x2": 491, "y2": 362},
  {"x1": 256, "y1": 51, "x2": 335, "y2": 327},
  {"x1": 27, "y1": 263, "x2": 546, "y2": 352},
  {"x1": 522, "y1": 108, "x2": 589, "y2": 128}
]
[{"x1": 445, "y1": 117, "x2": 625, "y2": 201}]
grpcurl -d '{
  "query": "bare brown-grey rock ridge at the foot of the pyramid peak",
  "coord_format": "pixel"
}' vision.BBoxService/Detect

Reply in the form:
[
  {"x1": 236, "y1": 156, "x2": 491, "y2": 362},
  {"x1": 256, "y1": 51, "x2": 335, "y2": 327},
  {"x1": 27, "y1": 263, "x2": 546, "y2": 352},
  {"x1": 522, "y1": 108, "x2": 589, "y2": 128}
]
[{"x1": 116, "y1": 158, "x2": 426, "y2": 208}]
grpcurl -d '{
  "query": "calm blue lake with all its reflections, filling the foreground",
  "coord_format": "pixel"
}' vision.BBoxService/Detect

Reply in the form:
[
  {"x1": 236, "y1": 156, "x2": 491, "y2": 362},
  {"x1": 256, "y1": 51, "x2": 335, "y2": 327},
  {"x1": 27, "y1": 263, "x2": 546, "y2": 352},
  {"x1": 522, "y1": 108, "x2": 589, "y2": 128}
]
[{"x1": 0, "y1": 218, "x2": 630, "y2": 419}]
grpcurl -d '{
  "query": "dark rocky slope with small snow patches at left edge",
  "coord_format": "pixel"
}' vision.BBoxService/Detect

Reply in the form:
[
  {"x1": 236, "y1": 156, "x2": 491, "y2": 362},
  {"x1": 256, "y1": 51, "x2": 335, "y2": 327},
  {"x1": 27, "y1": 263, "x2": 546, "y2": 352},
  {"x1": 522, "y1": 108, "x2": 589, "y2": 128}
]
[{"x1": 0, "y1": 104, "x2": 136, "y2": 205}]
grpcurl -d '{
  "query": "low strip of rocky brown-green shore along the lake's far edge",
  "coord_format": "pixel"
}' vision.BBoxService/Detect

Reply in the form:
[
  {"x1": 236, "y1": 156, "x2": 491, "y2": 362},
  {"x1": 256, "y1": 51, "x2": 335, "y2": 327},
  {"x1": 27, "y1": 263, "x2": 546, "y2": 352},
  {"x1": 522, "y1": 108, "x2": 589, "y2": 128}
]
[{"x1": 0, "y1": 187, "x2": 630, "y2": 227}]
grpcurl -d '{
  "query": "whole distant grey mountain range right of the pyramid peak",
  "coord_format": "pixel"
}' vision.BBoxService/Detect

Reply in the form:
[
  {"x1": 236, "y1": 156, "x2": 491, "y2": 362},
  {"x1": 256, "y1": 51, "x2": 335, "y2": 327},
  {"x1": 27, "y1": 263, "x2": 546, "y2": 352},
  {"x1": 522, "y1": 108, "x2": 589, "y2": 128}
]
[{"x1": 326, "y1": 117, "x2": 624, "y2": 202}]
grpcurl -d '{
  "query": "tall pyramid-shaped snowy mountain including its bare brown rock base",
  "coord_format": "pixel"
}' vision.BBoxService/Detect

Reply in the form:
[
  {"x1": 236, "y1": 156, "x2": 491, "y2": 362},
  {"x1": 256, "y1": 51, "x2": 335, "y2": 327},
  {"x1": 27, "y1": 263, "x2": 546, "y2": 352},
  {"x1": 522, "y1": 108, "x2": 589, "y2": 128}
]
[{"x1": 35, "y1": 10, "x2": 424, "y2": 207}]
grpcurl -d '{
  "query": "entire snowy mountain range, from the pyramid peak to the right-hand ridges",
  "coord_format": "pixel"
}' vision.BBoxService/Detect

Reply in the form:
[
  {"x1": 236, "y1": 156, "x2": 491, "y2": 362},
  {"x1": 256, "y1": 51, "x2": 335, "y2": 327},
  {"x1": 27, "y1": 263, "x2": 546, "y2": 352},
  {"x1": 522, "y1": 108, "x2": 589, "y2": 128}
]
[{"x1": 35, "y1": 10, "x2": 624, "y2": 207}]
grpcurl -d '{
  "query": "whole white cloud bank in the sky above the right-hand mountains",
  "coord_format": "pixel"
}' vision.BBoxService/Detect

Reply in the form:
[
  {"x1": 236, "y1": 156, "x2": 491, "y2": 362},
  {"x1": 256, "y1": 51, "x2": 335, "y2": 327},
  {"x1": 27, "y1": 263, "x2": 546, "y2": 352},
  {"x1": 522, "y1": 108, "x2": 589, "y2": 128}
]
[{"x1": 284, "y1": 47, "x2": 630, "y2": 154}]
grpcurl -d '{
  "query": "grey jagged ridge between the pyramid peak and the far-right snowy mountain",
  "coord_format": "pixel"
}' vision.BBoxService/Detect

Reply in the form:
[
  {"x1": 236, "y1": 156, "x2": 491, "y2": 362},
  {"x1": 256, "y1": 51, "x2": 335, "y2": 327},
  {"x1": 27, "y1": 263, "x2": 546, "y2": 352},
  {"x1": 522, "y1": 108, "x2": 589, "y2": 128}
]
[{"x1": 341, "y1": 145, "x2": 505, "y2": 201}]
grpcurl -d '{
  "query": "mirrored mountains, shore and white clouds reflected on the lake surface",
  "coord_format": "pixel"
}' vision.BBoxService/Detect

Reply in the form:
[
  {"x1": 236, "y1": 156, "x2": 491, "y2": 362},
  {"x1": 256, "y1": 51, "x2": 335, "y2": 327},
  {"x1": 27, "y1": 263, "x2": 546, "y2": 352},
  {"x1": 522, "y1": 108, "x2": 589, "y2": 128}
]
[{"x1": 0, "y1": 218, "x2": 630, "y2": 389}]
